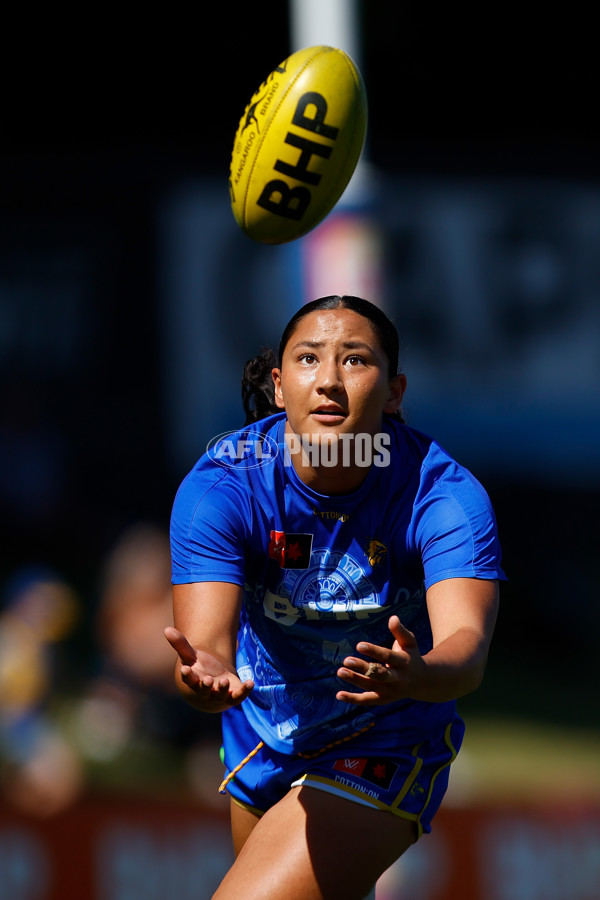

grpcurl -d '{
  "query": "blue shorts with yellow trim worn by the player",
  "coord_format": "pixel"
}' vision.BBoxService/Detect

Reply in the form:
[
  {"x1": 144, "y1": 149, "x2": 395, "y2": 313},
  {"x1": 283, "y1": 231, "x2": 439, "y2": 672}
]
[{"x1": 223, "y1": 707, "x2": 464, "y2": 837}]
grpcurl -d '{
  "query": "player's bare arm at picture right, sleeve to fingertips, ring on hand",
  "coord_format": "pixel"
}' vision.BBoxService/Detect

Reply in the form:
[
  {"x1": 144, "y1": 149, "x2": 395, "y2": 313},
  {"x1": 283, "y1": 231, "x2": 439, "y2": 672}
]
[{"x1": 337, "y1": 578, "x2": 498, "y2": 704}]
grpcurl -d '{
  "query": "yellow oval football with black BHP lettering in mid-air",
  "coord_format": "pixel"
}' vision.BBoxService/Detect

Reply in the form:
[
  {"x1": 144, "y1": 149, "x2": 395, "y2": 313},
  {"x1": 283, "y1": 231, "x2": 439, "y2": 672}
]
[{"x1": 229, "y1": 46, "x2": 367, "y2": 244}]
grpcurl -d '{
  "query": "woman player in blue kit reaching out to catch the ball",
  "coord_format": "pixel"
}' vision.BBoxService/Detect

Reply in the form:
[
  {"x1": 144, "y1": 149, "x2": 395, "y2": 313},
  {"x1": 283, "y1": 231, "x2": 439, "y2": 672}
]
[{"x1": 166, "y1": 296, "x2": 504, "y2": 900}]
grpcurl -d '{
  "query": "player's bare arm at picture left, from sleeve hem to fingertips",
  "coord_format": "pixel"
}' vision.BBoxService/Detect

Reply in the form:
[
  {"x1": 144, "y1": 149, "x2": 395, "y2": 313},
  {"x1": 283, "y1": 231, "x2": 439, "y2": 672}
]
[{"x1": 165, "y1": 581, "x2": 254, "y2": 712}]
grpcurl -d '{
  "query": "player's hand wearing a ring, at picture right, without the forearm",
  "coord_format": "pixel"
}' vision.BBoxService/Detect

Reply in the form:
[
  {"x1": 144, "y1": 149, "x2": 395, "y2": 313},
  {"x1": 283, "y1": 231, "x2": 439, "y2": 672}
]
[{"x1": 336, "y1": 616, "x2": 427, "y2": 706}]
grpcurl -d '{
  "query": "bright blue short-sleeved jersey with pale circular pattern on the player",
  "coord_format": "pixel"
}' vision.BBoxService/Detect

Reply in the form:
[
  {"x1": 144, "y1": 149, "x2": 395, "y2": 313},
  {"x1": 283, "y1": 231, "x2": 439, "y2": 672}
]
[{"x1": 171, "y1": 413, "x2": 504, "y2": 753}]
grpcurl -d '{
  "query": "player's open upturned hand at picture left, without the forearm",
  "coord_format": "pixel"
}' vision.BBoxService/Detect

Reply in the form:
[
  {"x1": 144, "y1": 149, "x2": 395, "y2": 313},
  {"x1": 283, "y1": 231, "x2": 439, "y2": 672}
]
[{"x1": 165, "y1": 626, "x2": 254, "y2": 712}]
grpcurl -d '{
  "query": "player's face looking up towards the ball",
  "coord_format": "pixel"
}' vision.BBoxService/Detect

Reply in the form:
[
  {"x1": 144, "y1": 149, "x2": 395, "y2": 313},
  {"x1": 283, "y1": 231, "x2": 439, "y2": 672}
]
[{"x1": 273, "y1": 309, "x2": 406, "y2": 440}]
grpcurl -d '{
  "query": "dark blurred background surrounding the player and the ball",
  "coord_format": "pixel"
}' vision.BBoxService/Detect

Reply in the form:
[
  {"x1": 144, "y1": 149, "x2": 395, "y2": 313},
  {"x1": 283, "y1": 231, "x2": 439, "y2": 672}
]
[{"x1": 0, "y1": 0, "x2": 600, "y2": 900}]
